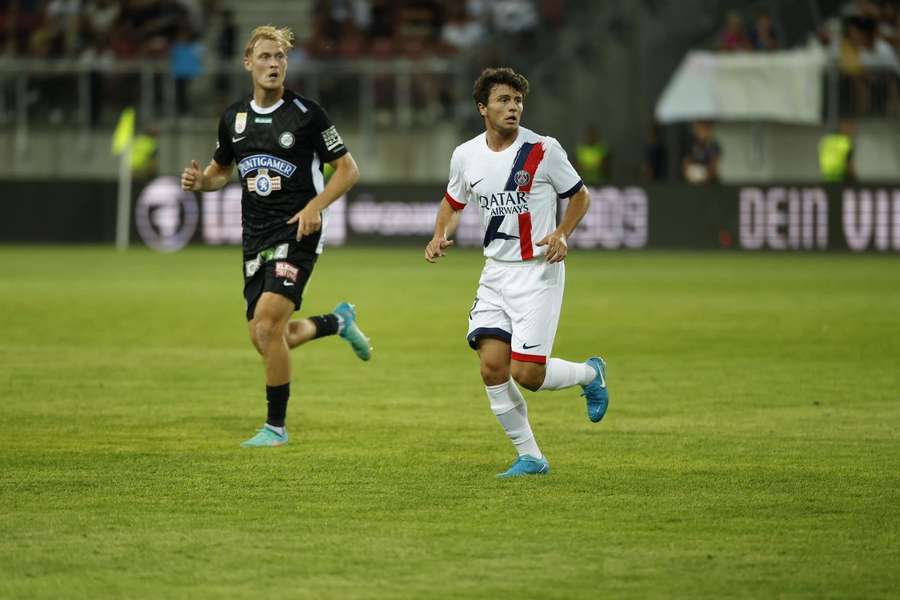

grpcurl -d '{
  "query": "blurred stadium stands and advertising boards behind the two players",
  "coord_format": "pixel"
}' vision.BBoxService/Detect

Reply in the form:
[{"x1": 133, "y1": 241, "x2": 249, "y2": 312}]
[{"x1": 0, "y1": 0, "x2": 900, "y2": 251}]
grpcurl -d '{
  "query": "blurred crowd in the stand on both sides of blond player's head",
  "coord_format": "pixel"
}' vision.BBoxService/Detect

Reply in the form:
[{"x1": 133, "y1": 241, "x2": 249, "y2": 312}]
[{"x1": 0, "y1": 0, "x2": 564, "y2": 58}]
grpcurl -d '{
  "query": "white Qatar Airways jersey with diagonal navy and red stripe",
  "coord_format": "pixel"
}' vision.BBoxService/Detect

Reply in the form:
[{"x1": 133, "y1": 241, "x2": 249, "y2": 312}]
[{"x1": 444, "y1": 127, "x2": 583, "y2": 261}]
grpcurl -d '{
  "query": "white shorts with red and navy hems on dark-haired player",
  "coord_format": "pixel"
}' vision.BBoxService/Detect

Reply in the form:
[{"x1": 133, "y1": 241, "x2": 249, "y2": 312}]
[{"x1": 466, "y1": 257, "x2": 566, "y2": 364}]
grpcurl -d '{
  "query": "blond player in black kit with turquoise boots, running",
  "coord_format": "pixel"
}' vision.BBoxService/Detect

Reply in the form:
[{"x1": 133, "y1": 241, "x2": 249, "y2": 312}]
[{"x1": 181, "y1": 25, "x2": 371, "y2": 448}]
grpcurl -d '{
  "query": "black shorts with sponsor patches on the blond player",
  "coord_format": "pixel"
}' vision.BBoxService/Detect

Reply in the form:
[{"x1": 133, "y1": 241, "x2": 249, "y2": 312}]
[{"x1": 244, "y1": 241, "x2": 319, "y2": 321}]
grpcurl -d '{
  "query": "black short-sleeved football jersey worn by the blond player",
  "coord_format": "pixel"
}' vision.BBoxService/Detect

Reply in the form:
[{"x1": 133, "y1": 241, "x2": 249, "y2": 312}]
[{"x1": 213, "y1": 89, "x2": 347, "y2": 256}]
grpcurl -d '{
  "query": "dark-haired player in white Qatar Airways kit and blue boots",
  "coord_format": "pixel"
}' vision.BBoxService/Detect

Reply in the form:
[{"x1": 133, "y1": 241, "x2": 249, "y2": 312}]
[{"x1": 425, "y1": 68, "x2": 609, "y2": 477}]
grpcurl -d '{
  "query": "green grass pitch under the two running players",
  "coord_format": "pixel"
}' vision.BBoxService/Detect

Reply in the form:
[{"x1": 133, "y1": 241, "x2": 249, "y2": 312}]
[{"x1": 0, "y1": 246, "x2": 900, "y2": 599}]
